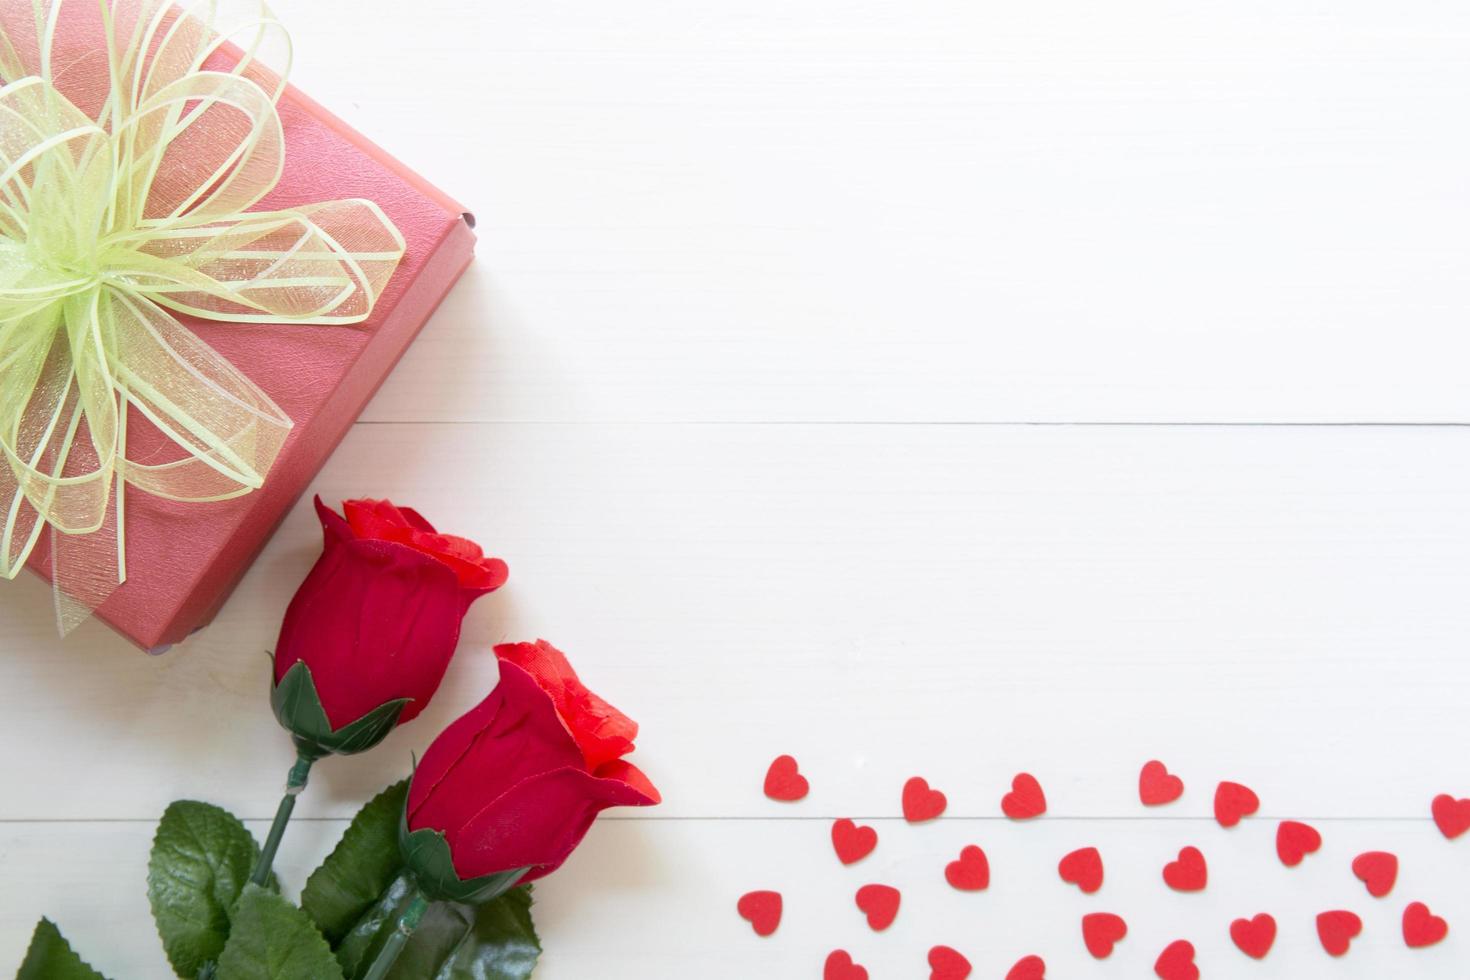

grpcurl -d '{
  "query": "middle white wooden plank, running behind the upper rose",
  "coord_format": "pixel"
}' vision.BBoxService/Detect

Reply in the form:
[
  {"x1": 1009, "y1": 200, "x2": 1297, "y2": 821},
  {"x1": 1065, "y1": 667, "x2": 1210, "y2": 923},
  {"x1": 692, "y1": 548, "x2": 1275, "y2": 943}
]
[{"x1": 0, "y1": 425, "x2": 1470, "y2": 820}]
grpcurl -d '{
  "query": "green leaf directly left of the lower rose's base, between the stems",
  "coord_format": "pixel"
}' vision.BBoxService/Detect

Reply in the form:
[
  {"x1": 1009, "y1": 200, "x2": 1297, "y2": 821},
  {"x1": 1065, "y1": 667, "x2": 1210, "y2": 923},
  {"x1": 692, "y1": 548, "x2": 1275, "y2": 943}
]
[{"x1": 301, "y1": 780, "x2": 409, "y2": 946}]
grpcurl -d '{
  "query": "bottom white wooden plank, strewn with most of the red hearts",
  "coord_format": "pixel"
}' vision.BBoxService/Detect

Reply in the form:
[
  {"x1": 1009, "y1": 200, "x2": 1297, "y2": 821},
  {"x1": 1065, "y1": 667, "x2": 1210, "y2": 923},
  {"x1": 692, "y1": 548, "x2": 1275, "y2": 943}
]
[{"x1": 0, "y1": 820, "x2": 1470, "y2": 980}]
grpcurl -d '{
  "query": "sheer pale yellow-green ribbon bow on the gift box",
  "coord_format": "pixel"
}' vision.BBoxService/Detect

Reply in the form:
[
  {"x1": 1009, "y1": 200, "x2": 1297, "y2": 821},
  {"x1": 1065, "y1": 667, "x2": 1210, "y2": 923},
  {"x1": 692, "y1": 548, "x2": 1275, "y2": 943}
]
[{"x1": 0, "y1": 0, "x2": 404, "y2": 632}]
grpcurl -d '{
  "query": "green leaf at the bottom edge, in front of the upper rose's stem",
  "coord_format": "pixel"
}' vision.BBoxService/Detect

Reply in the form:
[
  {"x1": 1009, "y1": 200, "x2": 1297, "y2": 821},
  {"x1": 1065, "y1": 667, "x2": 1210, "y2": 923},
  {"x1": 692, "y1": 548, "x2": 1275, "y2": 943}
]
[{"x1": 215, "y1": 884, "x2": 343, "y2": 980}]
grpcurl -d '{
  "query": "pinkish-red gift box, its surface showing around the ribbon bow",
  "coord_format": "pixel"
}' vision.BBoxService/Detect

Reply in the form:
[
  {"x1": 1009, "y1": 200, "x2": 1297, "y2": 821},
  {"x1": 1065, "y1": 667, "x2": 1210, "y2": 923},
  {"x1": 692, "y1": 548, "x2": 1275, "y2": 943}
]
[{"x1": 28, "y1": 78, "x2": 475, "y2": 652}]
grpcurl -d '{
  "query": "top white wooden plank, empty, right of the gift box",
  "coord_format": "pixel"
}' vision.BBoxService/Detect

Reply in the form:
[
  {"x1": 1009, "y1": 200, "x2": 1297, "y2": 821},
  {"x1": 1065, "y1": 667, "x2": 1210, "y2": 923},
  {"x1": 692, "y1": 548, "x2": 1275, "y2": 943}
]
[{"x1": 267, "y1": 0, "x2": 1470, "y2": 420}]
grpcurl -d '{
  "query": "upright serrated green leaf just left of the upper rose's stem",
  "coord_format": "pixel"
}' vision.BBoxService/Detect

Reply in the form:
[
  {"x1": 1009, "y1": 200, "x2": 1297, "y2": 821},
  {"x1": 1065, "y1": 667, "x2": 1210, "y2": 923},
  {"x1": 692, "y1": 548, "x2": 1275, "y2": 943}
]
[{"x1": 148, "y1": 799, "x2": 276, "y2": 977}]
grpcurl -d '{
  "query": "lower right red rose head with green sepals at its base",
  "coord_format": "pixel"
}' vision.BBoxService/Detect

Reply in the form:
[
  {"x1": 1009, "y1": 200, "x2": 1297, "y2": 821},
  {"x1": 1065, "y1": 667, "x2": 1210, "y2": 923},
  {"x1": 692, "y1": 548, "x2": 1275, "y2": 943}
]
[{"x1": 401, "y1": 642, "x2": 659, "y2": 902}]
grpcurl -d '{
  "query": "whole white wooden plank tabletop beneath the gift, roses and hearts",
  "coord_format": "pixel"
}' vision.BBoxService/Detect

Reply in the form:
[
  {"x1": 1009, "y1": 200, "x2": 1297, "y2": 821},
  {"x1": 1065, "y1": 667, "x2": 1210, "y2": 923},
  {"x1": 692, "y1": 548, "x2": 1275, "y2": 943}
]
[{"x1": 0, "y1": 0, "x2": 1470, "y2": 980}]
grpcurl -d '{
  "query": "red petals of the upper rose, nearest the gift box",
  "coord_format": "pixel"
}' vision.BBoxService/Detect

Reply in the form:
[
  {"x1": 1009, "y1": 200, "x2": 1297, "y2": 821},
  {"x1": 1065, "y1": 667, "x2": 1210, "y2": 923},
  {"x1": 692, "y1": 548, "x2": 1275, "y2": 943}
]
[{"x1": 275, "y1": 498, "x2": 507, "y2": 738}]
